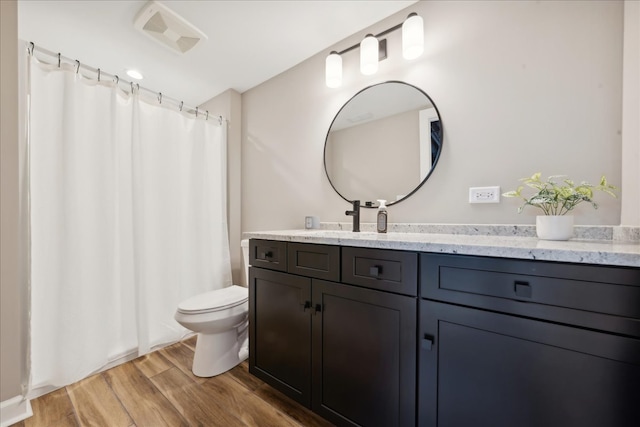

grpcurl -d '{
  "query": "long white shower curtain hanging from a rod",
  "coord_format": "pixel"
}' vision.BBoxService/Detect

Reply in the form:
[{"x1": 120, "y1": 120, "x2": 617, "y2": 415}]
[{"x1": 28, "y1": 58, "x2": 231, "y2": 390}]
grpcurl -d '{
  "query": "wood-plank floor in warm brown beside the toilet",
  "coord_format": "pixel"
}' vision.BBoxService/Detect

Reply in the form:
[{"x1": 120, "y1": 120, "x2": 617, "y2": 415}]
[{"x1": 14, "y1": 337, "x2": 332, "y2": 427}]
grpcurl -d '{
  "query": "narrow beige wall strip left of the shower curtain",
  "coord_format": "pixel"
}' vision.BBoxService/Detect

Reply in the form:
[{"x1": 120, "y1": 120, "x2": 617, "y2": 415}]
[{"x1": 0, "y1": 0, "x2": 26, "y2": 401}]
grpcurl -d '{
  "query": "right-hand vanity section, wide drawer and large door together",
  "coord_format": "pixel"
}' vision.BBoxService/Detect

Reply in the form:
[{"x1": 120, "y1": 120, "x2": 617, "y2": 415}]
[{"x1": 418, "y1": 254, "x2": 640, "y2": 427}]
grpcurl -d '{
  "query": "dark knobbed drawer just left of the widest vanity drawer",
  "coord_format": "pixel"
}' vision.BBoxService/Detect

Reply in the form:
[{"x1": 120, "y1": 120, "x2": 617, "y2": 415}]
[{"x1": 342, "y1": 247, "x2": 418, "y2": 296}]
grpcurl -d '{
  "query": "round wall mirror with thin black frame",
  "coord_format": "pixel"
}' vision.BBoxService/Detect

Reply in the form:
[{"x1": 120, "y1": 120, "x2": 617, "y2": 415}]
[{"x1": 324, "y1": 81, "x2": 442, "y2": 207}]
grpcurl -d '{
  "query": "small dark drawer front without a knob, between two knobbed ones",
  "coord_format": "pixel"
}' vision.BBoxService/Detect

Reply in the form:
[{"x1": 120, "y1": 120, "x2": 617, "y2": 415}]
[{"x1": 287, "y1": 243, "x2": 340, "y2": 282}]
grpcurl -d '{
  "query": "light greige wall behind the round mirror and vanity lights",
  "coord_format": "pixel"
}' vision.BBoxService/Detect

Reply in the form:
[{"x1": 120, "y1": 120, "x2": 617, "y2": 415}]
[{"x1": 242, "y1": 1, "x2": 640, "y2": 231}]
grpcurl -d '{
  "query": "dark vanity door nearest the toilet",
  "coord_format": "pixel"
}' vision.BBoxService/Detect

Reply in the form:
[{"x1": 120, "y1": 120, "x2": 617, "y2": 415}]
[{"x1": 249, "y1": 267, "x2": 311, "y2": 407}]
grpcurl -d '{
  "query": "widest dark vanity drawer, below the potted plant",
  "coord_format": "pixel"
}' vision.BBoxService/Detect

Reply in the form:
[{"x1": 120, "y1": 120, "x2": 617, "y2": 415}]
[{"x1": 421, "y1": 254, "x2": 640, "y2": 335}]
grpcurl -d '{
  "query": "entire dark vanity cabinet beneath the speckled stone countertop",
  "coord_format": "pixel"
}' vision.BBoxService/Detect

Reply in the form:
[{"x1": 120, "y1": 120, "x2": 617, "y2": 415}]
[{"x1": 249, "y1": 239, "x2": 640, "y2": 427}]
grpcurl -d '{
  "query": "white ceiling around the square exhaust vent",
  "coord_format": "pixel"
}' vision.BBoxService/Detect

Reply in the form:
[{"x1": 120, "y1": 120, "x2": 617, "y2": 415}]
[{"x1": 18, "y1": 0, "x2": 415, "y2": 106}]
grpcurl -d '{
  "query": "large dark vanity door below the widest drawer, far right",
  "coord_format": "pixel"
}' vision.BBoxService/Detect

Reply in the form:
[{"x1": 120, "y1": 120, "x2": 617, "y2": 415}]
[{"x1": 418, "y1": 300, "x2": 640, "y2": 427}]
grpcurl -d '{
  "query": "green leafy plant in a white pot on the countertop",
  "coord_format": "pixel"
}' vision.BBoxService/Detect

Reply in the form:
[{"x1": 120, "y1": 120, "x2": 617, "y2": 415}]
[{"x1": 503, "y1": 172, "x2": 617, "y2": 240}]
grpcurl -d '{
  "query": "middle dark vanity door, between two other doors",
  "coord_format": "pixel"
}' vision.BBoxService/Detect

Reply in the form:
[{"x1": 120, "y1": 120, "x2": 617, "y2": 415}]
[{"x1": 312, "y1": 280, "x2": 418, "y2": 427}]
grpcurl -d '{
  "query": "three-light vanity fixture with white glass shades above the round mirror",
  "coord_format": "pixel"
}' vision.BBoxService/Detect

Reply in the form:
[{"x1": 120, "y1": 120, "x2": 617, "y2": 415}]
[{"x1": 325, "y1": 12, "x2": 424, "y2": 88}]
